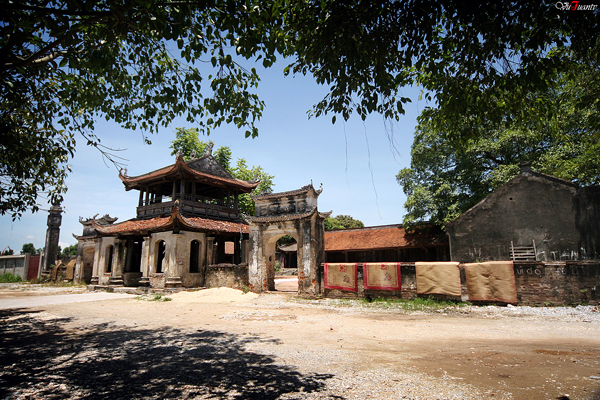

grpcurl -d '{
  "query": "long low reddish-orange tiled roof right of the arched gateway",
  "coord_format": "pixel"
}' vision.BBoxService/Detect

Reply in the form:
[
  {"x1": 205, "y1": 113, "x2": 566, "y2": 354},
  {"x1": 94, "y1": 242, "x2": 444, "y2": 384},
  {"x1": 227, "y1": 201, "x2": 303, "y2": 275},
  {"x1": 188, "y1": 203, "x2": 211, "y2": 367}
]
[{"x1": 325, "y1": 225, "x2": 448, "y2": 251}]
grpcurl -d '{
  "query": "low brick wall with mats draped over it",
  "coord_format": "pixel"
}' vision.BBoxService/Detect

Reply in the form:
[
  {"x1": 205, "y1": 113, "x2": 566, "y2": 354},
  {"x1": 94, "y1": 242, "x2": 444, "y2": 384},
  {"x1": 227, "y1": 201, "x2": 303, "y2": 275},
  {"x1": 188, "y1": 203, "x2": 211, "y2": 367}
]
[{"x1": 319, "y1": 261, "x2": 600, "y2": 306}]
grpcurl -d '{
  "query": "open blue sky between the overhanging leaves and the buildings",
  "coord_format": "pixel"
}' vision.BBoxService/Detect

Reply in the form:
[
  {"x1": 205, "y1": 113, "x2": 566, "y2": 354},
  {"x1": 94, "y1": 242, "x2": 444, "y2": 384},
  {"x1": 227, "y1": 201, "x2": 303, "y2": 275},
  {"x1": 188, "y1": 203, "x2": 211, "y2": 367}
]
[{"x1": 0, "y1": 62, "x2": 426, "y2": 253}]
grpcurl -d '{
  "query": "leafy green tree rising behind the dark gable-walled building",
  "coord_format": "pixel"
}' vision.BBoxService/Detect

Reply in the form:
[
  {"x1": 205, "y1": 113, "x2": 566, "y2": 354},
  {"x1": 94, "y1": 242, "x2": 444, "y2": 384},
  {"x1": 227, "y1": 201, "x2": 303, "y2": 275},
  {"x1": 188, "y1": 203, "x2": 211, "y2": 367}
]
[{"x1": 396, "y1": 74, "x2": 600, "y2": 227}]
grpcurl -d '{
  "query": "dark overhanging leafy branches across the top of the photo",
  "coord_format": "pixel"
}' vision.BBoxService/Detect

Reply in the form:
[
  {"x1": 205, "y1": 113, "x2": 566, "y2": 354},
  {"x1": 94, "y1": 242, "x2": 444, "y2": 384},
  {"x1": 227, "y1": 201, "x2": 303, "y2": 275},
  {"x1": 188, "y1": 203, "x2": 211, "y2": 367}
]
[{"x1": 0, "y1": 0, "x2": 600, "y2": 218}]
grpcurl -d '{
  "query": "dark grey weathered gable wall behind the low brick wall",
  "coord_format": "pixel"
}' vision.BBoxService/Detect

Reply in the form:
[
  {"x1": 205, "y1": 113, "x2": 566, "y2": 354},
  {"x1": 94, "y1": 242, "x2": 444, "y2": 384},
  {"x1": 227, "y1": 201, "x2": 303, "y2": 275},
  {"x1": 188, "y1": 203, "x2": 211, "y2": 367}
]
[{"x1": 446, "y1": 173, "x2": 600, "y2": 262}]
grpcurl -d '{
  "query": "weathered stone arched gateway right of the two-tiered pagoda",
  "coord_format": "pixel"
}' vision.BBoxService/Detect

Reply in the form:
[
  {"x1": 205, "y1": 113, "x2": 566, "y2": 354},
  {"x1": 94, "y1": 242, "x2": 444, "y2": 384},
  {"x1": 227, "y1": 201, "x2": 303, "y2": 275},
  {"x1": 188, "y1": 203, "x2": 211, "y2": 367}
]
[{"x1": 244, "y1": 184, "x2": 331, "y2": 295}]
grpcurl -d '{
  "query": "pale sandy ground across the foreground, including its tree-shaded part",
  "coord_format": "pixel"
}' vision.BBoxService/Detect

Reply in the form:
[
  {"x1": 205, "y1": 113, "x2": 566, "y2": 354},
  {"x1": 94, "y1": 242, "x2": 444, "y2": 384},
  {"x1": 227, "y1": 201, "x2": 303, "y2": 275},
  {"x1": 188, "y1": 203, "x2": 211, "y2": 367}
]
[{"x1": 0, "y1": 287, "x2": 600, "y2": 399}]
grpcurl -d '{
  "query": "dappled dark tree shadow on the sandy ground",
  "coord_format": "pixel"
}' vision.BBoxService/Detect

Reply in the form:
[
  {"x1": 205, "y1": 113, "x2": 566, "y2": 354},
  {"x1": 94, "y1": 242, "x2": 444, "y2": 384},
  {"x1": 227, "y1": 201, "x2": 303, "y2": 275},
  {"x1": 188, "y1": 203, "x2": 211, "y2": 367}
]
[{"x1": 0, "y1": 310, "x2": 332, "y2": 399}]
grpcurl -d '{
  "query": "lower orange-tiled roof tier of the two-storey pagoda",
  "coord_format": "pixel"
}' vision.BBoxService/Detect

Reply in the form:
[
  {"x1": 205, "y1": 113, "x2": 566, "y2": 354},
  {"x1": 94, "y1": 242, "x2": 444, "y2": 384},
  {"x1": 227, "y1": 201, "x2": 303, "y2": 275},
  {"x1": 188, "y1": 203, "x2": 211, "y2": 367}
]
[{"x1": 93, "y1": 207, "x2": 249, "y2": 235}]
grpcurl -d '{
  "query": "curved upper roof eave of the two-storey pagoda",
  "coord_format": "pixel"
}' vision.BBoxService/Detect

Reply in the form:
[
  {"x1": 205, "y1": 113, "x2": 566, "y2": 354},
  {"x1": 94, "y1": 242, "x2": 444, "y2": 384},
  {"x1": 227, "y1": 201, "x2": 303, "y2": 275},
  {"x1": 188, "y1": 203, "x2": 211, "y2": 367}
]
[{"x1": 119, "y1": 155, "x2": 260, "y2": 192}]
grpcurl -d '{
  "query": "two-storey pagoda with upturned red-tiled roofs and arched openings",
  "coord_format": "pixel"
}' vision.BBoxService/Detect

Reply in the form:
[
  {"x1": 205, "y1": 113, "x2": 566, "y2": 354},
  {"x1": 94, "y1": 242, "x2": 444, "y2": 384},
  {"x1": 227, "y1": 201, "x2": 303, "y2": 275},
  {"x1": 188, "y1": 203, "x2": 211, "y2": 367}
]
[{"x1": 76, "y1": 146, "x2": 259, "y2": 289}]
